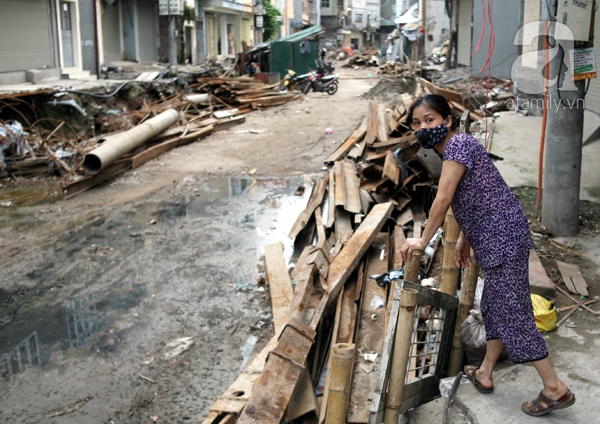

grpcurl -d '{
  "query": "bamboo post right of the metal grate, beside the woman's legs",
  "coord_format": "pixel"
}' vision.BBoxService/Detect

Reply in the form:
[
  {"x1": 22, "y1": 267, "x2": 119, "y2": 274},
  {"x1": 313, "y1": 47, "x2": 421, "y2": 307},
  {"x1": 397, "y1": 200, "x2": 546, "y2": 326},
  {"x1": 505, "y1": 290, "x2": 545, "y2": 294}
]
[{"x1": 448, "y1": 249, "x2": 479, "y2": 377}]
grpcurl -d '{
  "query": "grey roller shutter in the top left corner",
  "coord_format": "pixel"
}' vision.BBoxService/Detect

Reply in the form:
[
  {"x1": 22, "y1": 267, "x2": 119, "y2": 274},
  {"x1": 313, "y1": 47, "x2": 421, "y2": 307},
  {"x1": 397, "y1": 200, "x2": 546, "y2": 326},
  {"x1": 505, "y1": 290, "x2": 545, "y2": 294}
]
[{"x1": 0, "y1": 0, "x2": 56, "y2": 72}]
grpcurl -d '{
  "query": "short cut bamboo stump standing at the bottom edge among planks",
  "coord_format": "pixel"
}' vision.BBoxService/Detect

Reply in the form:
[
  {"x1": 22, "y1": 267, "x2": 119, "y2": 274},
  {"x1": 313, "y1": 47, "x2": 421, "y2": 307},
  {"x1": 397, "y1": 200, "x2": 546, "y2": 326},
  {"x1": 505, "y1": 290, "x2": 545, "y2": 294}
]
[{"x1": 325, "y1": 343, "x2": 356, "y2": 424}]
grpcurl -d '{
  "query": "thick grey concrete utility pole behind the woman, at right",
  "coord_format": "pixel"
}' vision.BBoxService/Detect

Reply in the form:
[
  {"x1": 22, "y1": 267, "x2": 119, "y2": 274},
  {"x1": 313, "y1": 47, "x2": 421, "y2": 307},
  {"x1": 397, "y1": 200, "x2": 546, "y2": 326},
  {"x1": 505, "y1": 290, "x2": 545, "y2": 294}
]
[{"x1": 542, "y1": 0, "x2": 596, "y2": 236}]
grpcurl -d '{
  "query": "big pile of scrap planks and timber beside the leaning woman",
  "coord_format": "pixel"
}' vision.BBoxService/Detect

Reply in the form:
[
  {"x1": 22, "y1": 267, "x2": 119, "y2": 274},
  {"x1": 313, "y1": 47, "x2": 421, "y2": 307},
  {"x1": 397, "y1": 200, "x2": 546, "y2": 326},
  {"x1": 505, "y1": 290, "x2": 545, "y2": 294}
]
[{"x1": 204, "y1": 83, "x2": 477, "y2": 424}]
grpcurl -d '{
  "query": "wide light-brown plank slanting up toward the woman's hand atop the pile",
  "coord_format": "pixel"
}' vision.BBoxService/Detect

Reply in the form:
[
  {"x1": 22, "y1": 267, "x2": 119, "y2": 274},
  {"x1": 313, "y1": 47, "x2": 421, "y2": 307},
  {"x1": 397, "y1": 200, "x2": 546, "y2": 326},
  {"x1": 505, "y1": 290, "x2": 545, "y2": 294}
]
[{"x1": 326, "y1": 203, "x2": 394, "y2": 302}]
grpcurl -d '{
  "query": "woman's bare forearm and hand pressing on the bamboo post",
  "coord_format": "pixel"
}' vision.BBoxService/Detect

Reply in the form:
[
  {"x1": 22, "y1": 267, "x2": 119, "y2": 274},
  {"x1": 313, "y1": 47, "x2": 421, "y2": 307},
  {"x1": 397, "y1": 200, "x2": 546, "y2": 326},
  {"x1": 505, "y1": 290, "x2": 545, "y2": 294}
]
[{"x1": 400, "y1": 160, "x2": 467, "y2": 261}]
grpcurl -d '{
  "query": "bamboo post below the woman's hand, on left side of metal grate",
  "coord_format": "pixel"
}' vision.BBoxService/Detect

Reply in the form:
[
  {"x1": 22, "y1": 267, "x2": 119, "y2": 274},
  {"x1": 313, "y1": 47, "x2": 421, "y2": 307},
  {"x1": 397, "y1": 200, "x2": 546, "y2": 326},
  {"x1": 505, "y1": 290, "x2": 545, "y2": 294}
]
[{"x1": 383, "y1": 288, "x2": 418, "y2": 424}]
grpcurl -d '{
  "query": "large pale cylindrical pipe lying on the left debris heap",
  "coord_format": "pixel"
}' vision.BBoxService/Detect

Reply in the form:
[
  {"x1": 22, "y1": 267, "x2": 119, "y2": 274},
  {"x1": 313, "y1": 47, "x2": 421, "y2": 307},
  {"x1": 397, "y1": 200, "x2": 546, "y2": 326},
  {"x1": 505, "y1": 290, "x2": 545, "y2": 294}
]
[{"x1": 83, "y1": 109, "x2": 179, "y2": 175}]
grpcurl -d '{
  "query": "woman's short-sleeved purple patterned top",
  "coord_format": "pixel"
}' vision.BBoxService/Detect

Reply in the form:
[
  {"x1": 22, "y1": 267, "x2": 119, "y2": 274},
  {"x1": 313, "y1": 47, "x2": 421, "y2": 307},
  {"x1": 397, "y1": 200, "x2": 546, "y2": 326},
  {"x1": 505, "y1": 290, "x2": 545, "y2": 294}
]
[{"x1": 444, "y1": 134, "x2": 535, "y2": 271}]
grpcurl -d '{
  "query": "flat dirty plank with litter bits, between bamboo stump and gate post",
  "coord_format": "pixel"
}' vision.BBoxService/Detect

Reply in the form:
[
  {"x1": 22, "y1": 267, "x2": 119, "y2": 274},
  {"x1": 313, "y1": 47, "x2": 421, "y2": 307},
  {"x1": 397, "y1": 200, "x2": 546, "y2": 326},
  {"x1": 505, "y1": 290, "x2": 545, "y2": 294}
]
[{"x1": 346, "y1": 233, "x2": 389, "y2": 423}]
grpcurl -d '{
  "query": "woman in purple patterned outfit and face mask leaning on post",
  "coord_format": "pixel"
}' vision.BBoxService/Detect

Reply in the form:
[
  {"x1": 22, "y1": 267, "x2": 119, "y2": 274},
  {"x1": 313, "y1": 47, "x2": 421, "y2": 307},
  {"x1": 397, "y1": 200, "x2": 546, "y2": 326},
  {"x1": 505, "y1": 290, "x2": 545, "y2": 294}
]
[{"x1": 400, "y1": 95, "x2": 575, "y2": 416}]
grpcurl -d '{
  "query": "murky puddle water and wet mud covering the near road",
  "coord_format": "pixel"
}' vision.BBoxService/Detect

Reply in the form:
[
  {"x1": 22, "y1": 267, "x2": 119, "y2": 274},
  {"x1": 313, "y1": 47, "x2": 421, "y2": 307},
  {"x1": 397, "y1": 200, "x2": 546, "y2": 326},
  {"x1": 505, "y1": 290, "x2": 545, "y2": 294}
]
[{"x1": 0, "y1": 176, "x2": 312, "y2": 423}]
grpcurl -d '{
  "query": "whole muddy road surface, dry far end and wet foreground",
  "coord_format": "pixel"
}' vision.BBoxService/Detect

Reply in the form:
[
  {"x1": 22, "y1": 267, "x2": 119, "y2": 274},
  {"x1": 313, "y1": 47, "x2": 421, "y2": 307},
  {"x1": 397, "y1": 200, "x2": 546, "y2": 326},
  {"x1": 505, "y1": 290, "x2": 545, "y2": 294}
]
[{"x1": 0, "y1": 70, "x2": 376, "y2": 423}]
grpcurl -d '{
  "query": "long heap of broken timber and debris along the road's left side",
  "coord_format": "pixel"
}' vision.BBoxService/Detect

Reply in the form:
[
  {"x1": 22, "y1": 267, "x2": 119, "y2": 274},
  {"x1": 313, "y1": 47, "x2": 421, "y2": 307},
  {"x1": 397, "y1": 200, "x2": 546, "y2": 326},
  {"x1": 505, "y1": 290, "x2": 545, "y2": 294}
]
[{"x1": 0, "y1": 77, "x2": 298, "y2": 203}]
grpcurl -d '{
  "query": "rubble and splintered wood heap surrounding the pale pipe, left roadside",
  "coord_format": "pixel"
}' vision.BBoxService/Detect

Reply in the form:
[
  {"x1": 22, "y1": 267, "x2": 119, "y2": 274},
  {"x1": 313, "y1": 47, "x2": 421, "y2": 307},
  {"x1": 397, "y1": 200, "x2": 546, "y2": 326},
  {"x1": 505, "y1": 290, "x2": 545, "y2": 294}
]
[{"x1": 0, "y1": 77, "x2": 299, "y2": 203}]
